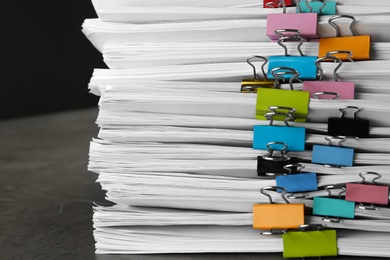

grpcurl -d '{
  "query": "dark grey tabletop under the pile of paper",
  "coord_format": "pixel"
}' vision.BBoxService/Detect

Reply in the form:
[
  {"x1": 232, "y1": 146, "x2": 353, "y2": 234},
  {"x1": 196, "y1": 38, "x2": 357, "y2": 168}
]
[{"x1": 0, "y1": 109, "x2": 384, "y2": 260}]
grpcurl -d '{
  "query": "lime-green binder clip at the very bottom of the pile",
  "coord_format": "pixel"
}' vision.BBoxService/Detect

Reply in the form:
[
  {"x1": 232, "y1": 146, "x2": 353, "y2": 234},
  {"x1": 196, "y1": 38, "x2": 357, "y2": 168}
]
[{"x1": 282, "y1": 225, "x2": 338, "y2": 258}]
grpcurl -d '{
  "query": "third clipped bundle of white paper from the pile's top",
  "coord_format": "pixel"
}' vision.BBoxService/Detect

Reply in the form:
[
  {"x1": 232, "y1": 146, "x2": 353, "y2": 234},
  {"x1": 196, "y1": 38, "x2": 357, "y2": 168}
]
[{"x1": 103, "y1": 42, "x2": 390, "y2": 68}]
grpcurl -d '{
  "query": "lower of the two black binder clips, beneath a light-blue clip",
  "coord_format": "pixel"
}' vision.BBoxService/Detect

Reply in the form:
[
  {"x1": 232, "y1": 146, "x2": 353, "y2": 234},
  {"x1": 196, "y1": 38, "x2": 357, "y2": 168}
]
[{"x1": 257, "y1": 142, "x2": 298, "y2": 176}]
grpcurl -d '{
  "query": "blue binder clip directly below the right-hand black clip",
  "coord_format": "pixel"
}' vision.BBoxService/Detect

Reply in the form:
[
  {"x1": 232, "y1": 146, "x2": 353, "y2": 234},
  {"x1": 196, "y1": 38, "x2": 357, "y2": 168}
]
[{"x1": 311, "y1": 136, "x2": 354, "y2": 168}]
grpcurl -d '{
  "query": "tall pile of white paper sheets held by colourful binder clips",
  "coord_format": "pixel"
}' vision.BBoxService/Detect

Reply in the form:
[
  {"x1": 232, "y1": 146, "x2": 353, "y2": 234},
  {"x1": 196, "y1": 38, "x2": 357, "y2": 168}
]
[{"x1": 83, "y1": 0, "x2": 390, "y2": 257}]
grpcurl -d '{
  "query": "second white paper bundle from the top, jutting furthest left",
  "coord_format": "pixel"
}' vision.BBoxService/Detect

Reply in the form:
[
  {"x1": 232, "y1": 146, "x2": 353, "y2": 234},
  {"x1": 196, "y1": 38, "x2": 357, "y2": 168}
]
[{"x1": 83, "y1": 14, "x2": 390, "y2": 51}]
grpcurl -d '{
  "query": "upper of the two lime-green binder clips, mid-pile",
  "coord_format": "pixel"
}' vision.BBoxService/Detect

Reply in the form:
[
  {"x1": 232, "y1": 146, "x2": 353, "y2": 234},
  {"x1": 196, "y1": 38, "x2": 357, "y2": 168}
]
[{"x1": 256, "y1": 67, "x2": 309, "y2": 122}]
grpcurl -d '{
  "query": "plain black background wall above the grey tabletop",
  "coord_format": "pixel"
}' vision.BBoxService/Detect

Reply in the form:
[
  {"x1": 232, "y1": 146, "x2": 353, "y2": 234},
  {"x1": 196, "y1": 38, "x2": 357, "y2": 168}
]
[{"x1": 0, "y1": 0, "x2": 106, "y2": 119}]
